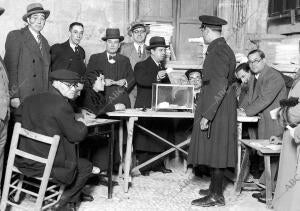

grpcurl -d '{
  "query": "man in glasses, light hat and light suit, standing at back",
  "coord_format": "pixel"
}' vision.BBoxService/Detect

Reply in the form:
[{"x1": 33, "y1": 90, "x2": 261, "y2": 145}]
[{"x1": 120, "y1": 21, "x2": 150, "y2": 108}]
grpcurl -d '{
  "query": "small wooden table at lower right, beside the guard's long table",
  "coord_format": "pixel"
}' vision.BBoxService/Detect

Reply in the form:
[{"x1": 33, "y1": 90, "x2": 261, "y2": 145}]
[{"x1": 235, "y1": 139, "x2": 281, "y2": 208}]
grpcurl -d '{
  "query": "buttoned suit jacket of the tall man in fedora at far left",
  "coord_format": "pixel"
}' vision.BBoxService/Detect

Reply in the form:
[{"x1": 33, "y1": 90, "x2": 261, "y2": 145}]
[{"x1": 4, "y1": 27, "x2": 50, "y2": 101}]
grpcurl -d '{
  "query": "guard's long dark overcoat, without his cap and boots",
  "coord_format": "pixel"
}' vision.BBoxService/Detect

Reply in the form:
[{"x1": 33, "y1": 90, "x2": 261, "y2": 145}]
[{"x1": 188, "y1": 37, "x2": 237, "y2": 168}]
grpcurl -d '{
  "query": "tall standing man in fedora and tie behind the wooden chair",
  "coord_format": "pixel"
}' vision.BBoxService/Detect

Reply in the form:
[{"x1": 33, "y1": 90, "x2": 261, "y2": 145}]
[{"x1": 4, "y1": 3, "x2": 50, "y2": 108}]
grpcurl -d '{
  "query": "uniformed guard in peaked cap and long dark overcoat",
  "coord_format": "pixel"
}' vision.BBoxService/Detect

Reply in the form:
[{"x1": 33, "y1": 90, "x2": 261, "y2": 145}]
[{"x1": 188, "y1": 15, "x2": 237, "y2": 207}]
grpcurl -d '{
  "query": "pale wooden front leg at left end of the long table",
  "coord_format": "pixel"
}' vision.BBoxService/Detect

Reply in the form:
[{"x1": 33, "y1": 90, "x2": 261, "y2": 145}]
[{"x1": 124, "y1": 117, "x2": 137, "y2": 193}]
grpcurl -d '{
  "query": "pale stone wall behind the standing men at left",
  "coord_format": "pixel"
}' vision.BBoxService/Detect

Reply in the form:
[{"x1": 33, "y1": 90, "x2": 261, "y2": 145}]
[{"x1": 0, "y1": 0, "x2": 128, "y2": 61}]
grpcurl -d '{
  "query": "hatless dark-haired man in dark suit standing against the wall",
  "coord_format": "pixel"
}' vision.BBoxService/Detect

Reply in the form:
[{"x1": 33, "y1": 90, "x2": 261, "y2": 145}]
[{"x1": 50, "y1": 22, "x2": 86, "y2": 76}]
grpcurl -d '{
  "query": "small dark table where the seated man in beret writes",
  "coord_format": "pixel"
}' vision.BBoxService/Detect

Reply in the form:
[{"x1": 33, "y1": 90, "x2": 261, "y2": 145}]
[{"x1": 85, "y1": 119, "x2": 121, "y2": 199}]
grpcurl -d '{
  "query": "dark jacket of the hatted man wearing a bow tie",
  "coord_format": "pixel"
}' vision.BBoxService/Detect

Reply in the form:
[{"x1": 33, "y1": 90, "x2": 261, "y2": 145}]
[{"x1": 87, "y1": 51, "x2": 135, "y2": 108}]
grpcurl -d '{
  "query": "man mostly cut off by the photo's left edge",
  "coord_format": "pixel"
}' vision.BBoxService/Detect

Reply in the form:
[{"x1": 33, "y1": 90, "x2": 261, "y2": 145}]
[{"x1": 0, "y1": 7, "x2": 9, "y2": 195}]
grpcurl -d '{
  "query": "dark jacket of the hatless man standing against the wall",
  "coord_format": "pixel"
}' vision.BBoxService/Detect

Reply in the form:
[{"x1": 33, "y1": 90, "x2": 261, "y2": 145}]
[{"x1": 50, "y1": 40, "x2": 86, "y2": 76}]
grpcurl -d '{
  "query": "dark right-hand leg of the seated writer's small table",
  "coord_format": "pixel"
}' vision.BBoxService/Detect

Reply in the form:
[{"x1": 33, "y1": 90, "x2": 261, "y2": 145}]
[{"x1": 108, "y1": 124, "x2": 115, "y2": 199}]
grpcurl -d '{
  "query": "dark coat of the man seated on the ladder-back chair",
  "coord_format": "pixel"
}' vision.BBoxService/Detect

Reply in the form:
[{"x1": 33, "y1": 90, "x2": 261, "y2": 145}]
[{"x1": 16, "y1": 87, "x2": 87, "y2": 184}]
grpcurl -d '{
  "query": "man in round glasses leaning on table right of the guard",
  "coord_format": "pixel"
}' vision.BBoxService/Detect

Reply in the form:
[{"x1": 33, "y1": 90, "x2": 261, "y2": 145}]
[{"x1": 239, "y1": 49, "x2": 287, "y2": 202}]
